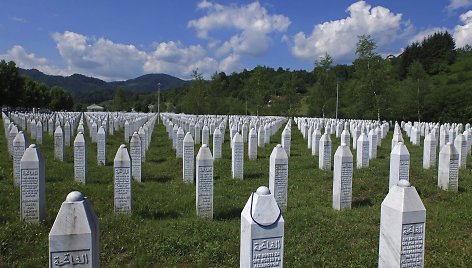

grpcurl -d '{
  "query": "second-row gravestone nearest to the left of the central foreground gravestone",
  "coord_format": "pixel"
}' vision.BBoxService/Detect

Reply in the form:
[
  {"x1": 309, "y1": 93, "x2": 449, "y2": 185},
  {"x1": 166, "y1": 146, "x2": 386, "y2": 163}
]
[{"x1": 195, "y1": 144, "x2": 213, "y2": 219}]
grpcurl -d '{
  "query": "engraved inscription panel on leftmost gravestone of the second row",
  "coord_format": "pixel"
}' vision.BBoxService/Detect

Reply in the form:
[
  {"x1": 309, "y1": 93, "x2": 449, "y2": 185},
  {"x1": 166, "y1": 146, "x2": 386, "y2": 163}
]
[{"x1": 21, "y1": 168, "x2": 39, "y2": 221}]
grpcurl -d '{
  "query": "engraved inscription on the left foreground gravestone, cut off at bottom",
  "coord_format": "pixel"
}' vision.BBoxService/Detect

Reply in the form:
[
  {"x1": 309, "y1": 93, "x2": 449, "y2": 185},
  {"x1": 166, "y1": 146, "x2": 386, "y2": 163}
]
[{"x1": 49, "y1": 249, "x2": 91, "y2": 267}]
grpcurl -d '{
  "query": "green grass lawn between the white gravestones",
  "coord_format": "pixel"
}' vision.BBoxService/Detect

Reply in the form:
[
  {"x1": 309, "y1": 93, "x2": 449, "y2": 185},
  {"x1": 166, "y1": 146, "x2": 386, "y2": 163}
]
[{"x1": 0, "y1": 117, "x2": 472, "y2": 267}]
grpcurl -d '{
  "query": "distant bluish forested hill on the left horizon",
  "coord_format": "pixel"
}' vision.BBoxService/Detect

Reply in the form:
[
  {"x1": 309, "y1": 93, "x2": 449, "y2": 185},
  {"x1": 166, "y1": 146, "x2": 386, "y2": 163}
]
[{"x1": 18, "y1": 68, "x2": 190, "y2": 103}]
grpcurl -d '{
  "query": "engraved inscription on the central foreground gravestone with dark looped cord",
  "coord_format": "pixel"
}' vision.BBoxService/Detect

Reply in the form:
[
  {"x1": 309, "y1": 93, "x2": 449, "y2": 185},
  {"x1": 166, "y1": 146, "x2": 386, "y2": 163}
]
[{"x1": 252, "y1": 236, "x2": 283, "y2": 267}]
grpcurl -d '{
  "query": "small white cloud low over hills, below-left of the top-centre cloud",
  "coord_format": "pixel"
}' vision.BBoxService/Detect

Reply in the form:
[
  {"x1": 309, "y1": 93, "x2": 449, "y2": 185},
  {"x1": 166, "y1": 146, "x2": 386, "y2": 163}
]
[{"x1": 143, "y1": 41, "x2": 218, "y2": 79}]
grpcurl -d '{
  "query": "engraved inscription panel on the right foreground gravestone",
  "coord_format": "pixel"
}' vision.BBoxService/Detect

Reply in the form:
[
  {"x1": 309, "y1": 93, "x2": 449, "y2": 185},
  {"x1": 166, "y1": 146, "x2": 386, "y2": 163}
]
[{"x1": 400, "y1": 222, "x2": 424, "y2": 268}]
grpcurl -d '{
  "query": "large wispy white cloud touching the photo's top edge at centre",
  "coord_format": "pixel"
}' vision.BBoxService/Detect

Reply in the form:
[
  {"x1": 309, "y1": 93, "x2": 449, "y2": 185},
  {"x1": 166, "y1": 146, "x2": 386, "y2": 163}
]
[{"x1": 188, "y1": 0, "x2": 291, "y2": 56}]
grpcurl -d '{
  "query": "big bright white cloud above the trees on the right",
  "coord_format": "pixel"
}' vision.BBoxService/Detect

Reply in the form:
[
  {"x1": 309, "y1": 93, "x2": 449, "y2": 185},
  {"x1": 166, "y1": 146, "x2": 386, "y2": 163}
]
[{"x1": 289, "y1": 1, "x2": 411, "y2": 61}]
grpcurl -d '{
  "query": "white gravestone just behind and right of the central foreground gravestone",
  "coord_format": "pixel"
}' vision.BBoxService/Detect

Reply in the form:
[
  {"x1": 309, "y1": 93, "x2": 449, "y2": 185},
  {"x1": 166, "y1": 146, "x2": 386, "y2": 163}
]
[{"x1": 269, "y1": 144, "x2": 288, "y2": 211}]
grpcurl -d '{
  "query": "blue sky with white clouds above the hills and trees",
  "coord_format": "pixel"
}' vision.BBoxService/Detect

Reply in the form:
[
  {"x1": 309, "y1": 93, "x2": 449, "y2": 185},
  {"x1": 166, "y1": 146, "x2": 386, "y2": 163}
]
[{"x1": 0, "y1": 0, "x2": 472, "y2": 81}]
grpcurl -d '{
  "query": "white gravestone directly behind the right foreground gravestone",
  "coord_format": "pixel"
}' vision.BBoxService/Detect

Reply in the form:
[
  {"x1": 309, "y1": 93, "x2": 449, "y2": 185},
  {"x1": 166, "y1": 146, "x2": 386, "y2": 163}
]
[{"x1": 388, "y1": 142, "x2": 410, "y2": 189}]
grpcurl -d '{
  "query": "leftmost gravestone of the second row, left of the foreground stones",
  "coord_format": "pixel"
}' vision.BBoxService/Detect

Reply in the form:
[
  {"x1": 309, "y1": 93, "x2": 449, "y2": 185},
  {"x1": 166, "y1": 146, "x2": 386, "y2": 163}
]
[{"x1": 20, "y1": 144, "x2": 46, "y2": 223}]
